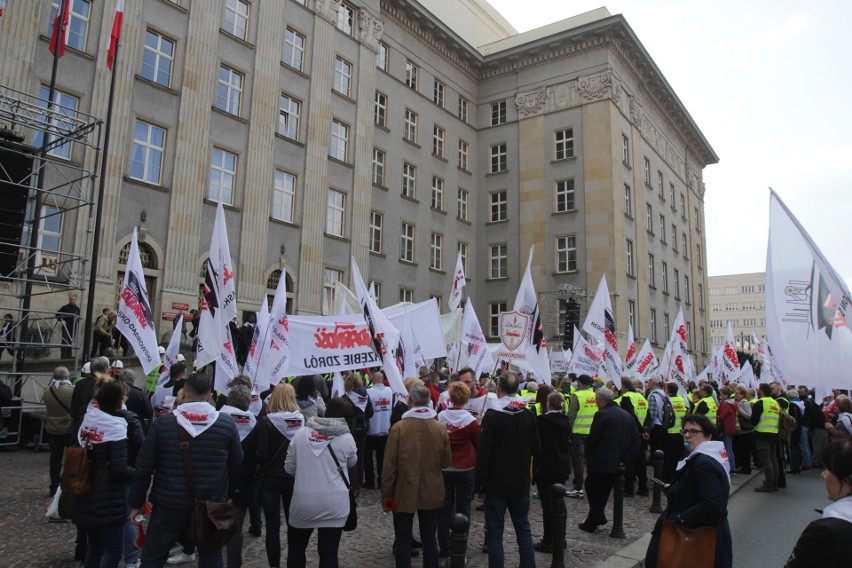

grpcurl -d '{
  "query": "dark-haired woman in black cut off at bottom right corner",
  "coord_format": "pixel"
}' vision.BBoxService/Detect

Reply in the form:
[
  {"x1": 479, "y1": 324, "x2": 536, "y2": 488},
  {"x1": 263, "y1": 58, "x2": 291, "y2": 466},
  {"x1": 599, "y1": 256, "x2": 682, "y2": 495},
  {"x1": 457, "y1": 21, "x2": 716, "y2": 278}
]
[{"x1": 785, "y1": 438, "x2": 852, "y2": 568}]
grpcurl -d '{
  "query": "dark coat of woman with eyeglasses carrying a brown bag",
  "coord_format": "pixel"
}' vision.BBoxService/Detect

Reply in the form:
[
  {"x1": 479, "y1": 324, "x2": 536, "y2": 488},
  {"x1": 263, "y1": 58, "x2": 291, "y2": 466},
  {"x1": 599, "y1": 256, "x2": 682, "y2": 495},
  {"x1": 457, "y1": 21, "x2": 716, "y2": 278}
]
[{"x1": 645, "y1": 455, "x2": 732, "y2": 568}]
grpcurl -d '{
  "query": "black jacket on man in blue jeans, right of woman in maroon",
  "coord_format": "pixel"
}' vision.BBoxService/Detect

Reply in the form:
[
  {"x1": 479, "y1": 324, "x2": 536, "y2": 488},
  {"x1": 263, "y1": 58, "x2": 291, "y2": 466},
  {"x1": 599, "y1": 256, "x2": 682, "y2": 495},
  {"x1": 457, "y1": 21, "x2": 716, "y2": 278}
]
[{"x1": 474, "y1": 408, "x2": 541, "y2": 497}]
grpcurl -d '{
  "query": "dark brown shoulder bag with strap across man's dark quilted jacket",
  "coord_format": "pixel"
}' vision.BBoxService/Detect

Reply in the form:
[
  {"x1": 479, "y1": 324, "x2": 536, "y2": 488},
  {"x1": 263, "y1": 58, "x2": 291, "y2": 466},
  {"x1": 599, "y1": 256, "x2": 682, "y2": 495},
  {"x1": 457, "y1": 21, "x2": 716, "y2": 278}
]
[{"x1": 177, "y1": 424, "x2": 239, "y2": 548}]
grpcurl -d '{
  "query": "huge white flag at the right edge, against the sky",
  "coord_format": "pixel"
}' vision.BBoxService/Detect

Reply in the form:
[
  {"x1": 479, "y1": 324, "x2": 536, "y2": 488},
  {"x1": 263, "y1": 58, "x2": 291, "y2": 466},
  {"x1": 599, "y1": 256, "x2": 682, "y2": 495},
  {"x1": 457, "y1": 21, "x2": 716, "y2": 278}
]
[{"x1": 766, "y1": 192, "x2": 852, "y2": 388}]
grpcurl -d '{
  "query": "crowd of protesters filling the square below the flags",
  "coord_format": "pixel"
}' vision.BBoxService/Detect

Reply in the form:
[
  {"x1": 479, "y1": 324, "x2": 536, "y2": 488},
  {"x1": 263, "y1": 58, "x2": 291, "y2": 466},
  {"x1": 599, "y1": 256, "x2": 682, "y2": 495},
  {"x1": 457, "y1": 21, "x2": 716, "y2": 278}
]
[{"x1": 36, "y1": 346, "x2": 852, "y2": 568}]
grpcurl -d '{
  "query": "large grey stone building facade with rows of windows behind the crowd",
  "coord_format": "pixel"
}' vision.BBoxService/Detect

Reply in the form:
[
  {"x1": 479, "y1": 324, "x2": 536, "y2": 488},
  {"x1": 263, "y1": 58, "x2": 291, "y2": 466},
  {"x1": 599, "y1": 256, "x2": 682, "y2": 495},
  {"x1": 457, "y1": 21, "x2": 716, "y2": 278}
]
[{"x1": 0, "y1": 0, "x2": 718, "y2": 358}]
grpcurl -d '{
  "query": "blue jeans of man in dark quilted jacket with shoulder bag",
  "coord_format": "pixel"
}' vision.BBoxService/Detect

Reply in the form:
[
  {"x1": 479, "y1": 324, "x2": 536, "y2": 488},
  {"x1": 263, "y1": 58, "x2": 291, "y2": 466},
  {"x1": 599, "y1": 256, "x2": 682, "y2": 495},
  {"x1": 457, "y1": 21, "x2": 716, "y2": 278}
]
[{"x1": 140, "y1": 505, "x2": 224, "y2": 568}]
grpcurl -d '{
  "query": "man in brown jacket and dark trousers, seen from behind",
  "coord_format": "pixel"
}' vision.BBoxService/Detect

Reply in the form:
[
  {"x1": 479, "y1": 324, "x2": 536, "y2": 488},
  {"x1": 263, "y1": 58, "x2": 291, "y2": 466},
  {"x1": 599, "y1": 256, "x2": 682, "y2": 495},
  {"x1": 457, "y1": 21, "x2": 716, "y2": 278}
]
[{"x1": 382, "y1": 385, "x2": 452, "y2": 568}]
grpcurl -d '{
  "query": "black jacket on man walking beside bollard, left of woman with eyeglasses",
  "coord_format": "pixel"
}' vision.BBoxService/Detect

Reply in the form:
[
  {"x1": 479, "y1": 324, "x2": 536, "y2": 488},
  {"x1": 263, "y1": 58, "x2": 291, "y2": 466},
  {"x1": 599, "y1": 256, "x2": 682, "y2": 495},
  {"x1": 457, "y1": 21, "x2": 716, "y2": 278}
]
[{"x1": 586, "y1": 402, "x2": 641, "y2": 474}]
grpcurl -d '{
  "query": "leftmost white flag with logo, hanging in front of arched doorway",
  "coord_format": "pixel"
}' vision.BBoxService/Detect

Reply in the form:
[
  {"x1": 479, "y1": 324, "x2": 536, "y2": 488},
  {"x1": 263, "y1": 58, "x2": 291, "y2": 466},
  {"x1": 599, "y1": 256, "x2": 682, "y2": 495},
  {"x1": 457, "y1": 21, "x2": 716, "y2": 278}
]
[{"x1": 115, "y1": 228, "x2": 160, "y2": 375}]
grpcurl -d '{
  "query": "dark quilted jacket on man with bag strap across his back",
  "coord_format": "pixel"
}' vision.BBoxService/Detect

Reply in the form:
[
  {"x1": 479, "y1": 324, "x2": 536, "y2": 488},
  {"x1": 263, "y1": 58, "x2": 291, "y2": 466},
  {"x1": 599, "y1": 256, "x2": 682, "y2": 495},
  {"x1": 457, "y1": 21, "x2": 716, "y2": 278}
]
[{"x1": 130, "y1": 412, "x2": 243, "y2": 509}]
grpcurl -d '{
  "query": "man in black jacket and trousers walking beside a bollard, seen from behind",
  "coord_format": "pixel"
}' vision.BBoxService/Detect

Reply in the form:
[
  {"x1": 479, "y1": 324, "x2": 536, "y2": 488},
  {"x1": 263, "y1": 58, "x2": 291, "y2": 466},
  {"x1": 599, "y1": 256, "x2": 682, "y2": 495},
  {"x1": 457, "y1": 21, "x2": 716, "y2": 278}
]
[{"x1": 580, "y1": 389, "x2": 641, "y2": 532}]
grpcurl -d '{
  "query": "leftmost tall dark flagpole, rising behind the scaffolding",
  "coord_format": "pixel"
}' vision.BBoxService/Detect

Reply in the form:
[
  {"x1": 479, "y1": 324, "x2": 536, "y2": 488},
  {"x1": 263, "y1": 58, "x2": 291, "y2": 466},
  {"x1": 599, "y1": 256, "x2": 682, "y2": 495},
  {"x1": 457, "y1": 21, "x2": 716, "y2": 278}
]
[{"x1": 15, "y1": 0, "x2": 68, "y2": 396}]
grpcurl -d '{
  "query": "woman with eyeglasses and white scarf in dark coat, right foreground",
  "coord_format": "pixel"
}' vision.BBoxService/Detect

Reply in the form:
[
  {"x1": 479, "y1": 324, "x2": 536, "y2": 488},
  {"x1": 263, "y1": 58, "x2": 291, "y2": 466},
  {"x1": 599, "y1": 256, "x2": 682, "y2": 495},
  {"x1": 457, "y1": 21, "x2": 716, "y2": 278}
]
[{"x1": 645, "y1": 414, "x2": 733, "y2": 568}]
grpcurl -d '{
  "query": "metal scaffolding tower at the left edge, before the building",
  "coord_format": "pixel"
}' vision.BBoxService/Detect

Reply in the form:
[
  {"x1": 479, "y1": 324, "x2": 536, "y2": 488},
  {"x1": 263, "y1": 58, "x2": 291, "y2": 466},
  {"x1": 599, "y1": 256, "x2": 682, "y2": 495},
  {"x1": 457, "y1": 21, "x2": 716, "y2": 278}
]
[{"x1": 0, "y1": 85, "x2": 103, "y2": 445}]
